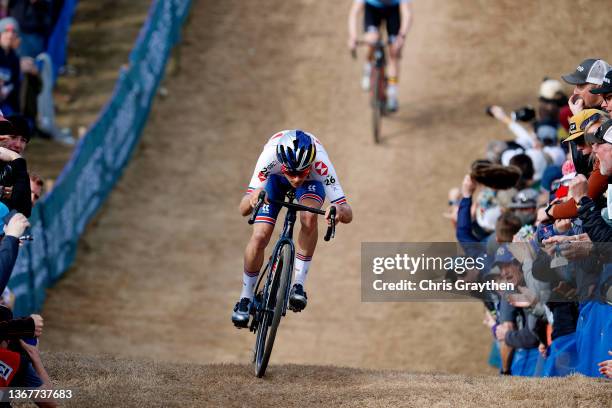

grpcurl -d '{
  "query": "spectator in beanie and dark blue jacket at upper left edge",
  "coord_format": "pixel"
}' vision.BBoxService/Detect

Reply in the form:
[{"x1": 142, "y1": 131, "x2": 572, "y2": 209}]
[{"x1": 0, "y1": 17, "x2": 21, "y2": 115}]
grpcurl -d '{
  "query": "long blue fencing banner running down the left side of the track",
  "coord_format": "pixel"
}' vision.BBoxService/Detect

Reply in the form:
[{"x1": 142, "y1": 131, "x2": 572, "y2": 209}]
[{"x1": 8, "y1": 0, "x2": 191, "y2": 316}]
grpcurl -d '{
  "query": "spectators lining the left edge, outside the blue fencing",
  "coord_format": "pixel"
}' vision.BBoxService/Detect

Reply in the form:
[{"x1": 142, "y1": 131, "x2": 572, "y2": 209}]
[{"x1": 0, "y1": 0, "x2": 73, "y2": 406}]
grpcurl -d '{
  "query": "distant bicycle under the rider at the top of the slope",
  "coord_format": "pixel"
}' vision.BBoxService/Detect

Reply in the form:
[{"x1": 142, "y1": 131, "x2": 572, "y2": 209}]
[{"x1": 351, "y1": 40, "x2": 387, "y2": 144}]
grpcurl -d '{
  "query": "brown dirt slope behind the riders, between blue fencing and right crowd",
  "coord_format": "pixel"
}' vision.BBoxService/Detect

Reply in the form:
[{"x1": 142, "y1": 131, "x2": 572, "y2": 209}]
[{"x1": 43, "y1": 0, "x2": 611, "y2": 384}]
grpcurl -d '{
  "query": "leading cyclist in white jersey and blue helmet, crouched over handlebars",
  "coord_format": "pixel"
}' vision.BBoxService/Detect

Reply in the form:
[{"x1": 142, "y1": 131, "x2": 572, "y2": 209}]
[{"x1": 232, "y1": 130, "x2": 353, "y2": 327}]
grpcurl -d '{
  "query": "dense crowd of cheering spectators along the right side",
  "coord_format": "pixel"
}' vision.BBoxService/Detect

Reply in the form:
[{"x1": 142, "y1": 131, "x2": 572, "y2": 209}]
[{"x1": 448, "y1": 58, "x2": 612, "y2": 378}]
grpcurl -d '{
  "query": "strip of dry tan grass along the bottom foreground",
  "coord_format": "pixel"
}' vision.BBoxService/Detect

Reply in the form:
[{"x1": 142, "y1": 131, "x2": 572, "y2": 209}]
[{"x1": 22, "y1": 353, "x2": 612, "y2": 408}]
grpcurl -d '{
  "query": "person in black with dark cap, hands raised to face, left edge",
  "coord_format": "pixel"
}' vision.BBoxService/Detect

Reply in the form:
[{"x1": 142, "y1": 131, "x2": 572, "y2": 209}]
[{"x1": 0, "y1": 117, "x2": 32, "y2": 217}]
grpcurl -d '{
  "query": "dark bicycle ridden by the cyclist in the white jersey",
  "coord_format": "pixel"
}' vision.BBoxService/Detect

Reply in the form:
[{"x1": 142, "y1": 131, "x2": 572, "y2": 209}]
[{"x1": 248, "y1": 189, "x2": 336, "y2": 378}]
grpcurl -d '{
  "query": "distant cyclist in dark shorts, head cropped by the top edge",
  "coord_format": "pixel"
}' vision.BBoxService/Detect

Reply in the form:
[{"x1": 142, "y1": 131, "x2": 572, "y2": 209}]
[{"x1": 348, "y1": 0, "x2": 412, "y2": 112}]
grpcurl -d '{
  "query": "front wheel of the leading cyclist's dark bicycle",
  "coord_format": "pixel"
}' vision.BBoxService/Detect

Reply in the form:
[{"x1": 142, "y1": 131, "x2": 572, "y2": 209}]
[{"x1": 255, "y1": 245, "x2": 293, "y2": 378}]
